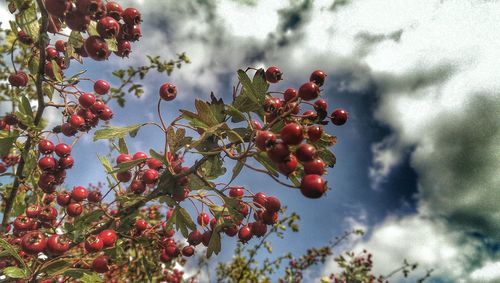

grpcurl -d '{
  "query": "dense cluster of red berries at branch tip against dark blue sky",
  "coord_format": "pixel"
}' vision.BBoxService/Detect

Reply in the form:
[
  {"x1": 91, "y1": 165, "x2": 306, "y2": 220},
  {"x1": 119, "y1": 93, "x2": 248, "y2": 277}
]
[{"x1": 253, "y1": 67, "x2": 347, "y2": 198}]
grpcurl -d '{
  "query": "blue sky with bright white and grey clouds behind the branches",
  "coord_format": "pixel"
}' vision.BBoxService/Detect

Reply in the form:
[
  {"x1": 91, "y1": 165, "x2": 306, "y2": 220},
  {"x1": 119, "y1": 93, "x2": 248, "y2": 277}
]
[{"x1": 1, "y1": 0, "x2": 500, "y2": 282}]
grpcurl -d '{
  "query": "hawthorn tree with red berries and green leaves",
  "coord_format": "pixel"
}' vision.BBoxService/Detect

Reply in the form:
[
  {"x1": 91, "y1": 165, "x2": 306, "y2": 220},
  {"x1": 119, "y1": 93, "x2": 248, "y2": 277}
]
[{"x1": 0, "y1": 0, "x2": 430, "y2": 283}]
